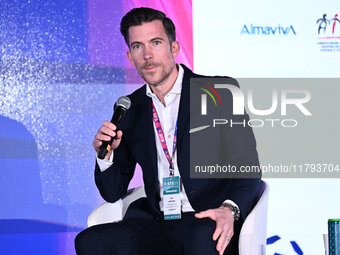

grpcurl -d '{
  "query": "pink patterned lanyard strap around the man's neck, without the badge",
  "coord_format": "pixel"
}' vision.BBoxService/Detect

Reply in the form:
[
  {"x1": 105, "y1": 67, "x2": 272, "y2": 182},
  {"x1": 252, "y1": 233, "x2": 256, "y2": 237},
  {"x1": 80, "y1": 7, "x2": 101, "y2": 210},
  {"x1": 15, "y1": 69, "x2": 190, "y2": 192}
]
[{"x1": 152, "y1": 102, "x2": 178, "y2": 177}]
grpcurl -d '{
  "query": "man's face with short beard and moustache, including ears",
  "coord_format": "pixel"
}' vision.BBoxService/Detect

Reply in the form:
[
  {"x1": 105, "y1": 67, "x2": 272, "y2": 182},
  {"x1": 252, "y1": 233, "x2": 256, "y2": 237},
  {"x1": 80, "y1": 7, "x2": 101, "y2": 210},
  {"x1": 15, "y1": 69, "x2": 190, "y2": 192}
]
[{"x1": 127, "y1": 20, "x2": 179, "y2": 87}]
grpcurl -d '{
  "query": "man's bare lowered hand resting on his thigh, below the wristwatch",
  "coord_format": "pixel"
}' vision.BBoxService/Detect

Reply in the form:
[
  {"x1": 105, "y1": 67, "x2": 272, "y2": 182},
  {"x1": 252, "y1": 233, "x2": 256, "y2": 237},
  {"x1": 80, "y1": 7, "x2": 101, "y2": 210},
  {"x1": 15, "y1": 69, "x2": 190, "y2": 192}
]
[{"x1": 195, "y1": 207, "x2": 234, "y2": 255}]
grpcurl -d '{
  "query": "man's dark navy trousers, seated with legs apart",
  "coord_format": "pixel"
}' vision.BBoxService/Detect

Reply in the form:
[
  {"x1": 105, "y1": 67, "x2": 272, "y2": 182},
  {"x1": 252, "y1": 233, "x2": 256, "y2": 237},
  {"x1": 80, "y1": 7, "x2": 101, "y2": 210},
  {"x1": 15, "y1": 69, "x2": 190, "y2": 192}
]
[{"x1": 75, "y1": 199, "x2": 240, "y2": 255}]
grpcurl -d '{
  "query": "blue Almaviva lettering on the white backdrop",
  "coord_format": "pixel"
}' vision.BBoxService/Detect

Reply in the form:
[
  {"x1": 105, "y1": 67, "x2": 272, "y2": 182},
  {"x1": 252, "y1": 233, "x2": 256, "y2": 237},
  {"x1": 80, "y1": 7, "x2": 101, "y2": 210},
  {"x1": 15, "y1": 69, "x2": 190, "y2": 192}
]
[{"x1": 241, "y1": 24, "x2": 296, "y2": 35}]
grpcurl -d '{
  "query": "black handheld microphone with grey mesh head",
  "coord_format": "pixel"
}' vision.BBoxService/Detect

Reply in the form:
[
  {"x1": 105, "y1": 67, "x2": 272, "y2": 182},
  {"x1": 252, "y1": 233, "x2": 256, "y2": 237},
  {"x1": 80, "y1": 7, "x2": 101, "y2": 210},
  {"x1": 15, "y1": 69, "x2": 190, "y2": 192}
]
[{"x1": 98, "y1": 97, "x2": 131, "y2": 159}]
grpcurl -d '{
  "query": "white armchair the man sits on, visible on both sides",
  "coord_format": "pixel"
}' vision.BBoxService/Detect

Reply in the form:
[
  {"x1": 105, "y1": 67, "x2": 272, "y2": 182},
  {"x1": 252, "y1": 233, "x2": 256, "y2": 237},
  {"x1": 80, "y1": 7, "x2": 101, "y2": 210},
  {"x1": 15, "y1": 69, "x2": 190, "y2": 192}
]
[{"x1": 87, "y1": 181, "x2": 269, "y2": 255}]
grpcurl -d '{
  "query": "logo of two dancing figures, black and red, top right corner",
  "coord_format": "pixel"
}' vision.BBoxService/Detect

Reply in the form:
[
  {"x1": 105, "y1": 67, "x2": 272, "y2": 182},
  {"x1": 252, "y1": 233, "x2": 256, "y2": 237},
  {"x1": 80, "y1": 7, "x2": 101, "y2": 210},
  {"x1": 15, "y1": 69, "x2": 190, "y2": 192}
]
[{"x1": 315, "y1": 13, "x2": 340, "y2": 52}]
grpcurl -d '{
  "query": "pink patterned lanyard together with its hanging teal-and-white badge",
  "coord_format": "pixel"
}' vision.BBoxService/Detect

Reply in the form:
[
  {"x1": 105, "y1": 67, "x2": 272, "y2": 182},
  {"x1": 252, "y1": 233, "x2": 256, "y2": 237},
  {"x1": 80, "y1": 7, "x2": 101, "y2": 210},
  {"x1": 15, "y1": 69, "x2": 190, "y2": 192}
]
[{"x1": 152, "y1": 103, "x2": 181, "y2": 220}]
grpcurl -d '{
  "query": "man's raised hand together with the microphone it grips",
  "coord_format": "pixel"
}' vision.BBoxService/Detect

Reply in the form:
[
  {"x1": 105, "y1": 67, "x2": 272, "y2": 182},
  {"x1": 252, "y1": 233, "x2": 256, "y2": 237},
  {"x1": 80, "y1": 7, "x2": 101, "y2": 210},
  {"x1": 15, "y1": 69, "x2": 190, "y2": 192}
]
[{"x1": 92, "y1": 97, "x2": 131, "y2": 159}]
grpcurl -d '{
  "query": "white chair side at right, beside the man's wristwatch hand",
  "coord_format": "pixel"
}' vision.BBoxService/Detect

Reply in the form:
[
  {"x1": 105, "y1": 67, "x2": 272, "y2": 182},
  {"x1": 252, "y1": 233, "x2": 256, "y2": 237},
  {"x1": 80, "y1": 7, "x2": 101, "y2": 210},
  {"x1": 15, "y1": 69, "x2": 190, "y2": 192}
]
[{"x1": 239, "y1": 181, "x2": 269, "y2": 255}]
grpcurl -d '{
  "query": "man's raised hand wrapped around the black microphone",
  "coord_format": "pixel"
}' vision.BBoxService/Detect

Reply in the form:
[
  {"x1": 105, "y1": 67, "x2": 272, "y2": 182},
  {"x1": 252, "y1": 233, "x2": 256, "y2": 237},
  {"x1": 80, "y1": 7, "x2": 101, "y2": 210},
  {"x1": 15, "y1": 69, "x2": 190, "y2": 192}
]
[{"x1": 92, "y1": 120, "x2": 123, "y2": 160}]
